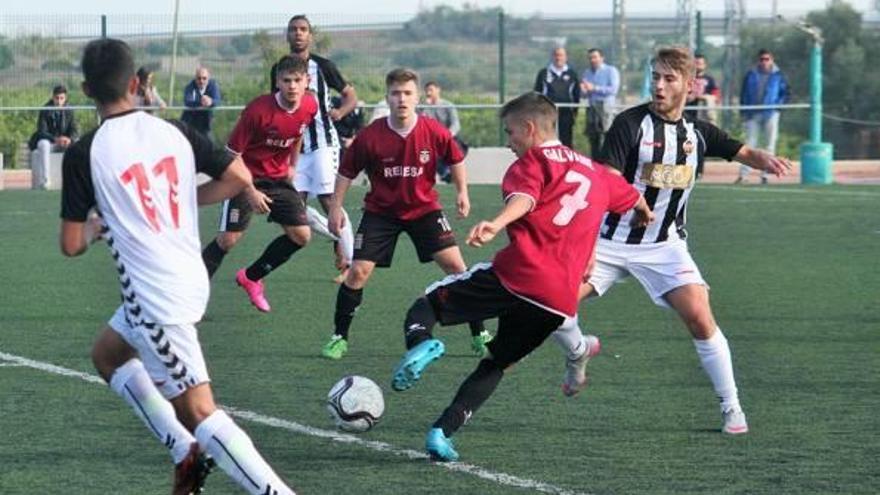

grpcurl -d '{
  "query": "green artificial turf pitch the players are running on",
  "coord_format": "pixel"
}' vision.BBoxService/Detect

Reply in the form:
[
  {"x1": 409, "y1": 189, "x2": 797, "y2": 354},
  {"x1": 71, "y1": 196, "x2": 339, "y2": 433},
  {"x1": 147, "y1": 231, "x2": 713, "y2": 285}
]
[{"x1": 0, "y1": 185, "x2": 880, "y2": 495}]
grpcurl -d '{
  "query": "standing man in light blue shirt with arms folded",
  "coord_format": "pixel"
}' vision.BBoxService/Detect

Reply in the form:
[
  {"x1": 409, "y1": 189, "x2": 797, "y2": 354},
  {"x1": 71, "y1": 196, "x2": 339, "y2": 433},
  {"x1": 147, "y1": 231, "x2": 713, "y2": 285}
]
[{"x1": 581, "y1": 48, "x2": 620, "y2": 156}]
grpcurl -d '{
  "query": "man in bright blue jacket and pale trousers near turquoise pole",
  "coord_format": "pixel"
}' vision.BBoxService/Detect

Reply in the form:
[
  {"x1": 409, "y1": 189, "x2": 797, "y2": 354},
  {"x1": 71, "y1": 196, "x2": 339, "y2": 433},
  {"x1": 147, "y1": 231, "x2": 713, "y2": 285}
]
[{"x1": 735, "y1": 48, "x2": 788, "y2": 184}]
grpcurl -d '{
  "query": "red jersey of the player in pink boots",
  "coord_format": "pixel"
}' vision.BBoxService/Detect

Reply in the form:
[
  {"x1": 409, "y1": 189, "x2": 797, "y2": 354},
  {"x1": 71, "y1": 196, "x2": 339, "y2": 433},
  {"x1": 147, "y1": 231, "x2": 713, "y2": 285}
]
[{"x1": 226, "y1": 93, "x2": 318, "y2": 179}]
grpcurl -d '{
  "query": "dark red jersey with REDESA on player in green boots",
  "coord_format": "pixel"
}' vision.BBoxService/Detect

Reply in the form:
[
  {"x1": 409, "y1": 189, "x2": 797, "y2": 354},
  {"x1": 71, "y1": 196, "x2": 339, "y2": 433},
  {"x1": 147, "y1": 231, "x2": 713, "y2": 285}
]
[{"x1": 339, "y1": 115, "x2": 464, "y2": 220}]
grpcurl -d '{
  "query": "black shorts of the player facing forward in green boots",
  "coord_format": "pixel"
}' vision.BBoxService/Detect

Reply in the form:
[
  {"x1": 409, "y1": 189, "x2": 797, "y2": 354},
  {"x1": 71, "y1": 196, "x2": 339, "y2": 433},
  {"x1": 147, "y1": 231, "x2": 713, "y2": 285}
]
[{"x1": 354, "y1": 210, "x2": 456, "y2": 268}]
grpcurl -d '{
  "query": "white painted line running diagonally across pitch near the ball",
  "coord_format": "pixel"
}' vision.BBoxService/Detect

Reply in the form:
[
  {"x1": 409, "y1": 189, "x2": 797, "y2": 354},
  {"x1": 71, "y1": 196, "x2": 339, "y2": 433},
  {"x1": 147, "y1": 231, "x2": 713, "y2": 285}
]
[{"x1": 0, "y1": 351, "x2": 586, "y2": 495}]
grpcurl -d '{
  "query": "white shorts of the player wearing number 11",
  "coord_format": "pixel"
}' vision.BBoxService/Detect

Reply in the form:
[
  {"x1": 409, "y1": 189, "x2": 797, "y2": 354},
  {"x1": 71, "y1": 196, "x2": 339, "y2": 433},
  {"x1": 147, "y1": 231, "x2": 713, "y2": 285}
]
[{"x1": 108, "y1": 306, "x2": 211, "y2": 400}]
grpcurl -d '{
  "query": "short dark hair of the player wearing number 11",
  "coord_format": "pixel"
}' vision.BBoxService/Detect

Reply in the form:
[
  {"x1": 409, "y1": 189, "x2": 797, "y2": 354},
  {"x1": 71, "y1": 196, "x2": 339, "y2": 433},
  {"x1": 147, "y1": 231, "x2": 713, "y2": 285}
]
[{"x1": 80, "y1": 38, "x2": 134, "y2": 103}]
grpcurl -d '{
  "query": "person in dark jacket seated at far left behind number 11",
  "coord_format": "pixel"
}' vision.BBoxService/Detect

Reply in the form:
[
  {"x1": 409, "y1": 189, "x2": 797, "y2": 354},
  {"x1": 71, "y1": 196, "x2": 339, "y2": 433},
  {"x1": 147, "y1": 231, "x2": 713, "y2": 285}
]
[{"x1": 28, "y1": 84, "x2": 79, "y2": 189}]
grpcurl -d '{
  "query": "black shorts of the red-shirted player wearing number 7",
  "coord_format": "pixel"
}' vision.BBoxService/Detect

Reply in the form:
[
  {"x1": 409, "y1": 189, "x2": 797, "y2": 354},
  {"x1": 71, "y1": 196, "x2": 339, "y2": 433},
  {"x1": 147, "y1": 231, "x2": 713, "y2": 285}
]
[{"x1": 426, "y1": 263, "x2": 565, "y2": 368}]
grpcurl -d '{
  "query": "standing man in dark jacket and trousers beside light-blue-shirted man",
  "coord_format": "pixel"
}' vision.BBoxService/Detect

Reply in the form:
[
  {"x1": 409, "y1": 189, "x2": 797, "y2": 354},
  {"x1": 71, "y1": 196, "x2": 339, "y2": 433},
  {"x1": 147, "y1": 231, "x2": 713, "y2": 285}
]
[{"x1": 535, "y1": 46, "x2": 581, "y2": 148}]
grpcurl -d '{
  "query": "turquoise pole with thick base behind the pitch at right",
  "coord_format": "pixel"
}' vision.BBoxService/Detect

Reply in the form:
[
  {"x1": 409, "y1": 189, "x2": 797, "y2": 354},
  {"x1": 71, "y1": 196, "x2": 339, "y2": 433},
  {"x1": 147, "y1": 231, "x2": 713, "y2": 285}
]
[{"x1": 797, "y1": 22, "x2": 834, "y2": 184}]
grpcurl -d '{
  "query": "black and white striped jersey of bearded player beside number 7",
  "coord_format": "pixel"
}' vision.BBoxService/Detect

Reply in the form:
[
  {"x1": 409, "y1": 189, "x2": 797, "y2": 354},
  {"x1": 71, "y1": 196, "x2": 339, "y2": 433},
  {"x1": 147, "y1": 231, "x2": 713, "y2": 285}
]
[{"x1": 598, "y1": 103, "x2": 743, "y2": 244}]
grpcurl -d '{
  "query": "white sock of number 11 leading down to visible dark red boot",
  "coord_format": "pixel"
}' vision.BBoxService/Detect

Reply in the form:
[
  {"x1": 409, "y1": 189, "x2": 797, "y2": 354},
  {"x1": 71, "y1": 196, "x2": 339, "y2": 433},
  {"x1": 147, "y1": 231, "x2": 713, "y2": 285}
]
[{"x1": 110, "y1": 359, "x2": 196, "y2": 464}]
